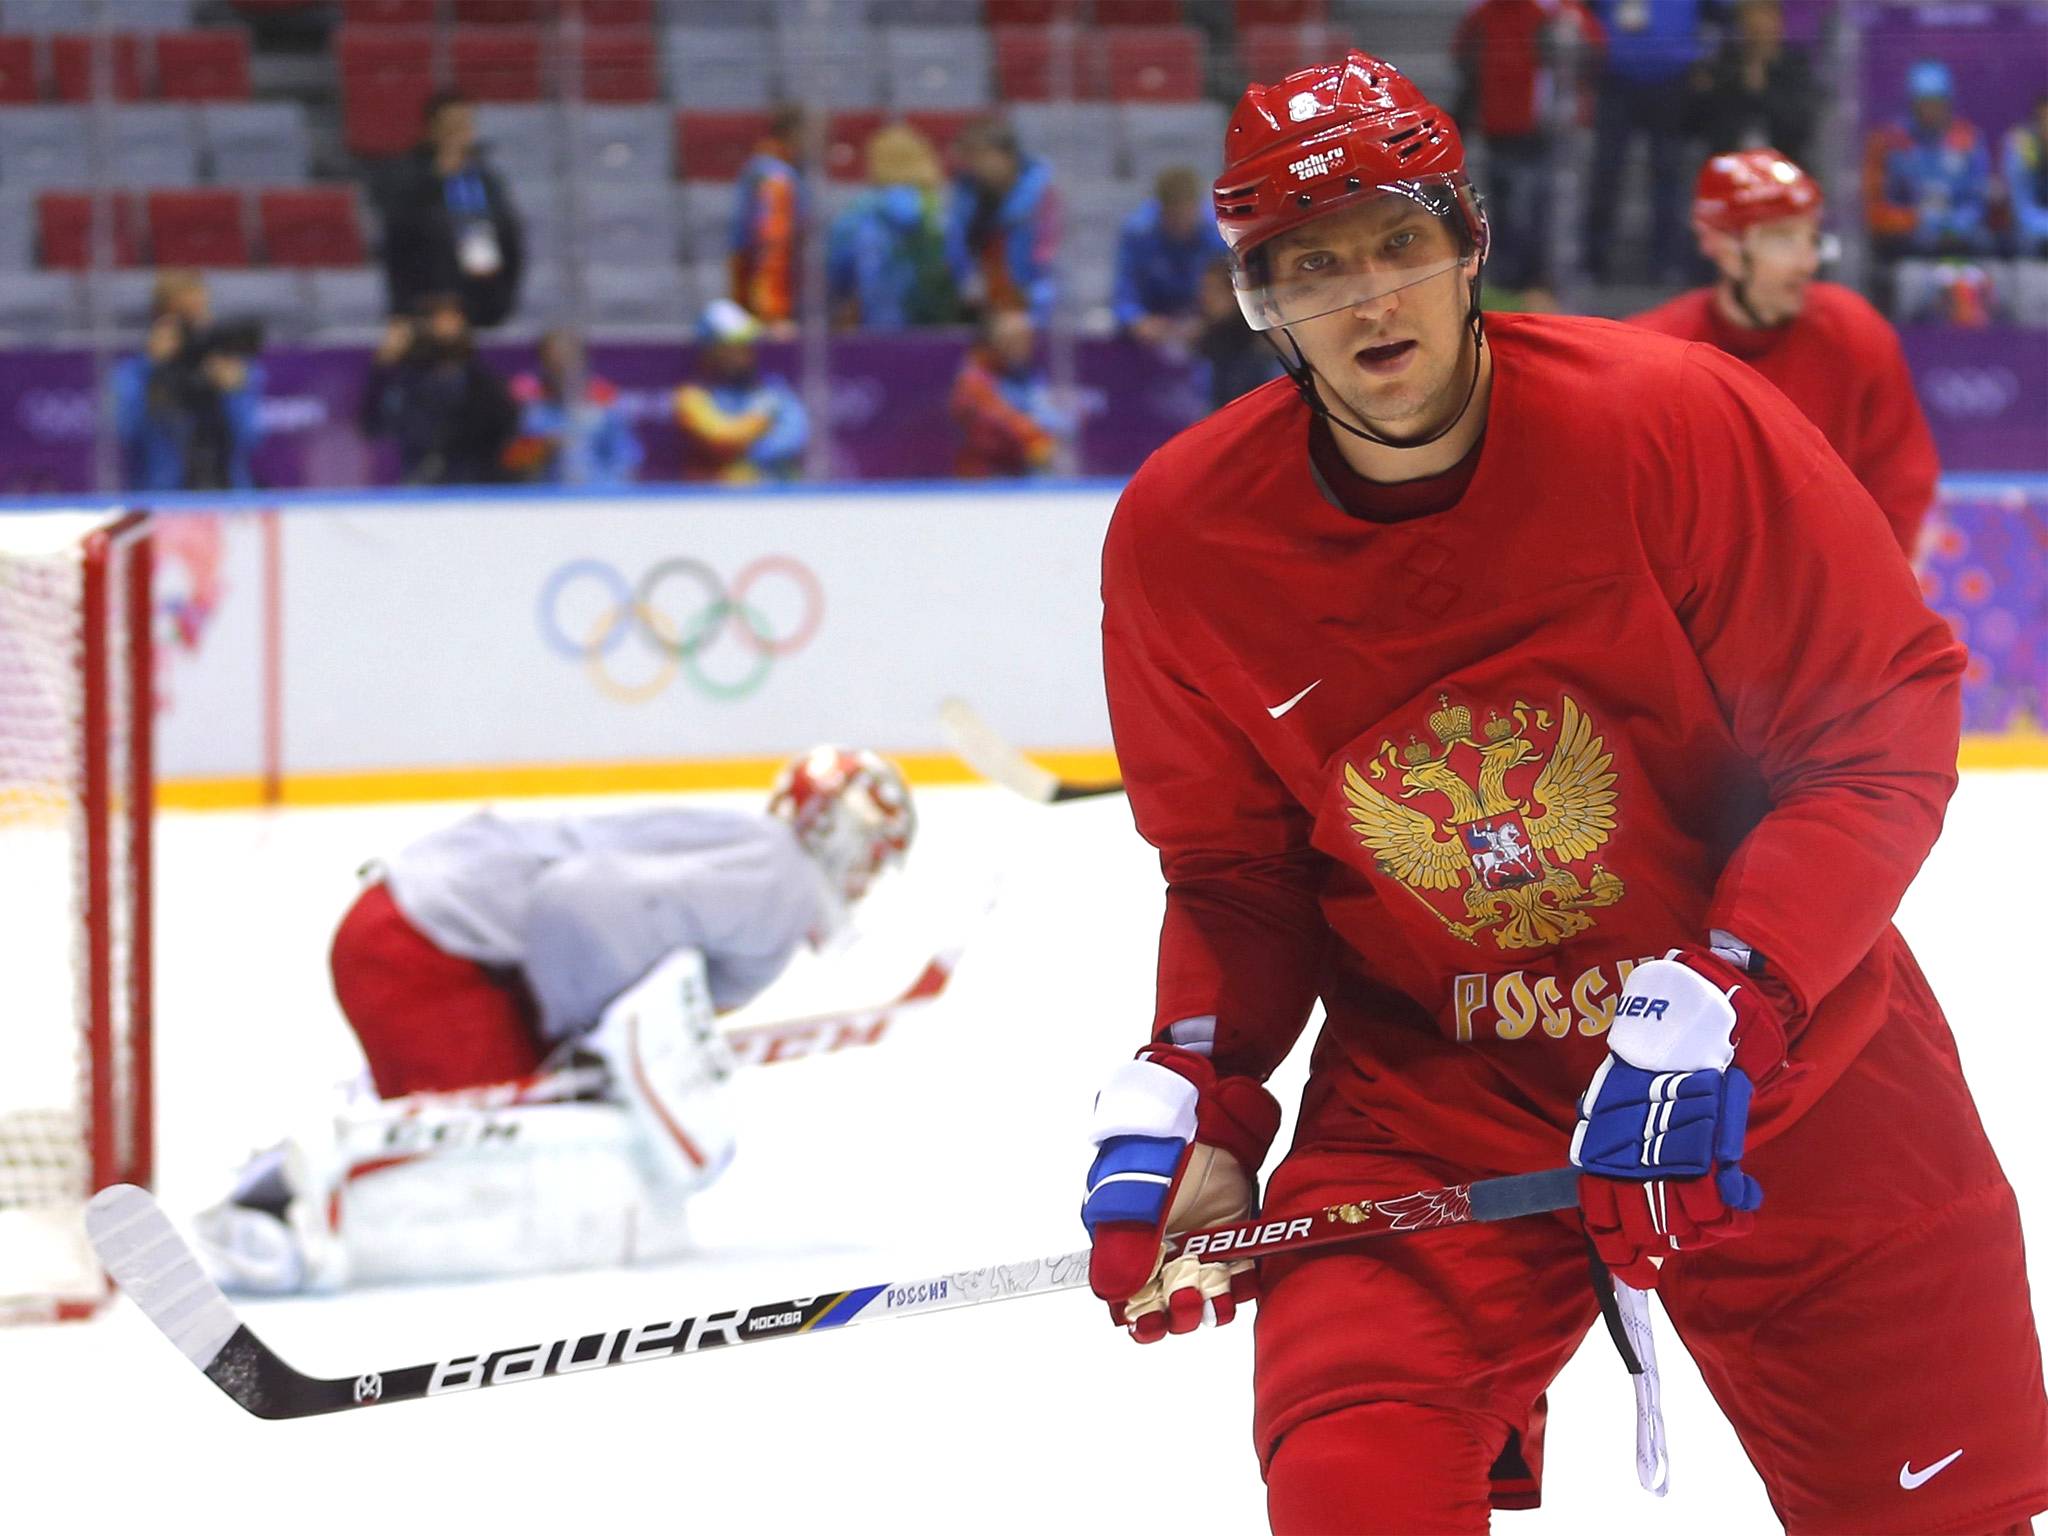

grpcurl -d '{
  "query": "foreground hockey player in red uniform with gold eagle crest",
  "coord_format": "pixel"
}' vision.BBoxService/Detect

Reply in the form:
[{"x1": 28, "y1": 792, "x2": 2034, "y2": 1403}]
[{"x1": 1083, "y1": 53, "x2": 2048, "y2": 1532}]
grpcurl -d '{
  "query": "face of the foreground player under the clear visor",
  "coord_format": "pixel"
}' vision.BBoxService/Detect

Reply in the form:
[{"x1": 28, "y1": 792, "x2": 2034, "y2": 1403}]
[{"x1": 1274, "y1": 197, "x2": 1473, "y2": 432}]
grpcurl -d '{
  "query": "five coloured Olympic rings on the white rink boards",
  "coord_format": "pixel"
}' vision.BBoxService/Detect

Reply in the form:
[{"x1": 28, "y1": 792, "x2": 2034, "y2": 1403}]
[{"x1": 539, "y1": 555, "x2": 825, "y2": 705}]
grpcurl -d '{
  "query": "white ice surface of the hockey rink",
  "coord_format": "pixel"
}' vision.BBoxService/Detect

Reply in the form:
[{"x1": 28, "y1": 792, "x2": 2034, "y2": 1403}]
[{"x1": 0, "y1": 774, "x2": 2048, "y2": 1536}]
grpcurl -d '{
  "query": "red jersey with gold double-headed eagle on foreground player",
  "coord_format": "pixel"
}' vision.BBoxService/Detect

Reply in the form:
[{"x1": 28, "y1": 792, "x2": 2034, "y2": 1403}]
[{"x1": 1102, "y1": 315, "x2": 1964, "y2": 1171}]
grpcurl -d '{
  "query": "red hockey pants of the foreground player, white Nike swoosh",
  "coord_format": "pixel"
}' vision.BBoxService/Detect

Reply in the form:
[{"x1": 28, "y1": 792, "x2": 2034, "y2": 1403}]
[{"x1": 1255, "y1": 991, "x2": 2048, "y2": 1536}]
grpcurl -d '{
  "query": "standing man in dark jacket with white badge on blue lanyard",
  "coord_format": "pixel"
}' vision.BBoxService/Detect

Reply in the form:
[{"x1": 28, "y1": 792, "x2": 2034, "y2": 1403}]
[{"x1": 383, "y1": 90, "x2": 526, "y2": 330}]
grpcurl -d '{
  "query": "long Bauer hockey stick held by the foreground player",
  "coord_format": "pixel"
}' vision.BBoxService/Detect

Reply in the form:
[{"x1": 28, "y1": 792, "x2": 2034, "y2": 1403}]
[{"x1": 86, "y1": 1167, "x2": 1579, "y2": 1419}]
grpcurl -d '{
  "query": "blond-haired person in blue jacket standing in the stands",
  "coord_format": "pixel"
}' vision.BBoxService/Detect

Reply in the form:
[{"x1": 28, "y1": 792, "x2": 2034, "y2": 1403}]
[{"x1": 825, "y1": 123, "x2": 961, "y2": 330}]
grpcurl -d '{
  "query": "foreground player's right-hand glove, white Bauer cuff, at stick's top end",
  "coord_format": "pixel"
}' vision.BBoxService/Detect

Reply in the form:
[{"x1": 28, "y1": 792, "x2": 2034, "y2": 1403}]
[{"x1": 1571, "y1": 948, "x2": 1786, "y2": 1290}]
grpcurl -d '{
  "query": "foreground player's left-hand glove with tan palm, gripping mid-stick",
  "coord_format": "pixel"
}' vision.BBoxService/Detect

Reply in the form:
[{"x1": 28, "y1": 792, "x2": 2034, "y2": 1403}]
[{"x1": 1081, "y1": 1044, "x2": 1280, "y2": 1343}]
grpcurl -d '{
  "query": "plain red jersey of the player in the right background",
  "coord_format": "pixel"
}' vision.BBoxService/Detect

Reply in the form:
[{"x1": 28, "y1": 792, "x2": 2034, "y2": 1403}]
[{"x1": 1630, "y1": 283, "x2": 1942, "y2": 559}]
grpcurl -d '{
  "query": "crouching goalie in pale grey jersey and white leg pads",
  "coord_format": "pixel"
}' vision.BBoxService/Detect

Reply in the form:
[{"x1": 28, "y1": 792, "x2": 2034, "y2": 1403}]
[{"x1": 197, "y1": 748, "x2": 915, "y2": 1290}]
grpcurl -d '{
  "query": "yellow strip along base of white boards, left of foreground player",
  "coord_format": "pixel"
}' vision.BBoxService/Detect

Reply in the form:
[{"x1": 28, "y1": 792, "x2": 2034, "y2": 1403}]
[{"x1": 156, "y1": 750, "x2": 1116, "y2": 811}]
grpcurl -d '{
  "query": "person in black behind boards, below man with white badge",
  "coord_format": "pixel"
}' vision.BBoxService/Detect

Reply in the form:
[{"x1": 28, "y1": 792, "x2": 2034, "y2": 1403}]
[{"x1": 362, "y1": 293, "x2": 518, "y2": 485}]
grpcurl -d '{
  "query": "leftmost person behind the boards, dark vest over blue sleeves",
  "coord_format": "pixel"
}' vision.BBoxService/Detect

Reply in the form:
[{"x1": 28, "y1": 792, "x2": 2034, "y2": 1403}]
[{"x1": 111, "y1": 270, "x2": 264, "y2": 492}]
